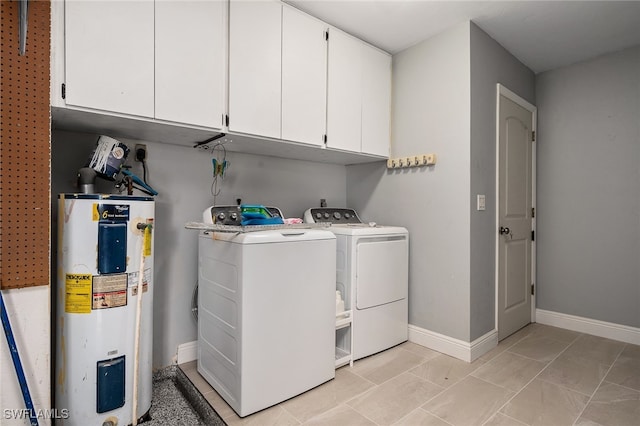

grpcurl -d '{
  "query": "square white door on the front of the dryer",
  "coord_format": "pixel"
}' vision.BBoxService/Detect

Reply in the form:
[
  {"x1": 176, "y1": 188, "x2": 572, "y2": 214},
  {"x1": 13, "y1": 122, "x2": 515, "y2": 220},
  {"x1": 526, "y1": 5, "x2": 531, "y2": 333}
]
[{"x1": 356, "y1": 235, "x2": 409, "y2": 309}]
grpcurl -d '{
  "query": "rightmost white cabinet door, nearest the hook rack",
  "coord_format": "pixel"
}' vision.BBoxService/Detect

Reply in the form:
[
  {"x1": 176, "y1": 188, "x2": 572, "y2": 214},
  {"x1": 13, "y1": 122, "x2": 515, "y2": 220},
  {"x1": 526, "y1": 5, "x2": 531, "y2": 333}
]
[{"x1": 362, "y1": 45, "x2": 391, "y2": 157}]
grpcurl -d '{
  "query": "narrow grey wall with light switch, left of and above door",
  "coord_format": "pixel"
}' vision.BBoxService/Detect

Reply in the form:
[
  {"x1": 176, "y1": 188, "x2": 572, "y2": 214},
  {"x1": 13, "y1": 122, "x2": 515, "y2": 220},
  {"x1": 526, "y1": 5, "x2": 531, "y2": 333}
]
[{"x1": 469, "y1": 23, "x2": 535, "y2": 341}]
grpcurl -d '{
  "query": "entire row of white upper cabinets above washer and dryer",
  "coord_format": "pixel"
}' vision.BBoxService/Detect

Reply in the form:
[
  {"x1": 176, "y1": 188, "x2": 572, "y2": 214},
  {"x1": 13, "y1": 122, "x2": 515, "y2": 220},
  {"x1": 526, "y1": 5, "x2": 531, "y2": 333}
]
[{"x1": 57, "y1": 0, "x2": 391, "y2": 162}]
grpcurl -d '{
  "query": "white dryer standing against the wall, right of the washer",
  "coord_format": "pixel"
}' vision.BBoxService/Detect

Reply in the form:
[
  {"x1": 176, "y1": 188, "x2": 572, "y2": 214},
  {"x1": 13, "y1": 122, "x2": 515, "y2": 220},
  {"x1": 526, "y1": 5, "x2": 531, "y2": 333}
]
[{"x1": 304, "y1": 207, "x2": 409, "y2": 360}]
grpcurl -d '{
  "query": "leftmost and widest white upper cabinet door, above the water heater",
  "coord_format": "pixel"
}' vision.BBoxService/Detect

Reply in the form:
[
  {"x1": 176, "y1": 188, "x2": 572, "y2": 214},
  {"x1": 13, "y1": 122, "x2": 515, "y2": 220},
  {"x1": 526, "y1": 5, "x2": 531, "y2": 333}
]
[{"x1": 65, "y1": 0, "x2": 154, "y2": 117}]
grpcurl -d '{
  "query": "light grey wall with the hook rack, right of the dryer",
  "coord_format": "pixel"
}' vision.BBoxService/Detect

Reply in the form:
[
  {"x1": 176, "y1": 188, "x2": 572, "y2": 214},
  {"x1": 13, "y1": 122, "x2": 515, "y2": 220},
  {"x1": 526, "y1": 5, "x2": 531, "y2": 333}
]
[{"x1": 347, "y1": 23, "x2": 470, "y2": 341}]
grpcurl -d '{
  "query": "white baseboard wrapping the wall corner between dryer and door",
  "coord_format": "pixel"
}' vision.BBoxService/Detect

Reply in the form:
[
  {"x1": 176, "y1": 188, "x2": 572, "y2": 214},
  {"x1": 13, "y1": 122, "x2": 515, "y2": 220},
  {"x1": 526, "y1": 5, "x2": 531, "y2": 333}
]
[{"x1": 409, "y1": 324, "x2": 498, "y2": 362}]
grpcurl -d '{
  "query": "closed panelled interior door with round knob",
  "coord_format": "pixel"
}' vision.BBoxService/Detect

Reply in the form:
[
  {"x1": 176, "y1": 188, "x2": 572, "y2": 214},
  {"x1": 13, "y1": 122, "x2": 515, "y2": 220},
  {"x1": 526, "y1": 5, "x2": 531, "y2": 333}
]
[{"x1": 498, "y1": 95, "x2": 533, "y2": 339}]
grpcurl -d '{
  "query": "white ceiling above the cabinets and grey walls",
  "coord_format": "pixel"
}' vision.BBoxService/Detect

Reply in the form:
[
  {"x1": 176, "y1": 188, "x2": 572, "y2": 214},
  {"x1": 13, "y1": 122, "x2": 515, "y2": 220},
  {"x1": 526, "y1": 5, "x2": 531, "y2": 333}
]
[{"x1": 286, "y1": 0, "x2": 640, "y2": 73}]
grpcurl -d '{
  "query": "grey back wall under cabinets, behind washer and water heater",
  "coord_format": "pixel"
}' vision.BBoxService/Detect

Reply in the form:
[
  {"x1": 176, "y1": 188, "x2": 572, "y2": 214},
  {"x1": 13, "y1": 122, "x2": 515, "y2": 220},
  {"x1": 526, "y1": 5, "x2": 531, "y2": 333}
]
[{"x1": 52, "y1": 132, "x2": 346, "y2": 368}]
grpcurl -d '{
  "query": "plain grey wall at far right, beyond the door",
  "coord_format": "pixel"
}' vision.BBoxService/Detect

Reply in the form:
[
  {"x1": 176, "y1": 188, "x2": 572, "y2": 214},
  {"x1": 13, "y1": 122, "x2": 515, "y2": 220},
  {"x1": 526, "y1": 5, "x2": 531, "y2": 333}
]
[{"x1": 536, "y1": 46, "x2": 640, "y2": 327}]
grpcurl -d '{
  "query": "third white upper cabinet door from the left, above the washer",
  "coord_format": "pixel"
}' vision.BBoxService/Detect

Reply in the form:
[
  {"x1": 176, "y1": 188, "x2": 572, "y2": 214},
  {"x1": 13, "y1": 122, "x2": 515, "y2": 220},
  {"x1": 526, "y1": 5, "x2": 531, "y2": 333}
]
[{"x1": 229, "y1": 0, "x2": 282, "y2": 138}]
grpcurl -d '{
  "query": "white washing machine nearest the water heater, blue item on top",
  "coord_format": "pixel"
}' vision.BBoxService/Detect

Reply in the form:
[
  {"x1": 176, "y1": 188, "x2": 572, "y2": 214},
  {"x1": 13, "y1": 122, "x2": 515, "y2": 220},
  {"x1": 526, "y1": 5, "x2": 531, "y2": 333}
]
[{"x1": 197, "y1": 206, "x2": 336, "y2": 417}]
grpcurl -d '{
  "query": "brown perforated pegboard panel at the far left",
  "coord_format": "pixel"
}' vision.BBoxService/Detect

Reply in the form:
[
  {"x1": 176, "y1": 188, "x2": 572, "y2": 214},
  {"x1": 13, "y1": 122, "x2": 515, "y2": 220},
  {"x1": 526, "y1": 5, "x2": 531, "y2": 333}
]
[{"x1": 0, "y1": 1, "x2": 51, "y2": 289}]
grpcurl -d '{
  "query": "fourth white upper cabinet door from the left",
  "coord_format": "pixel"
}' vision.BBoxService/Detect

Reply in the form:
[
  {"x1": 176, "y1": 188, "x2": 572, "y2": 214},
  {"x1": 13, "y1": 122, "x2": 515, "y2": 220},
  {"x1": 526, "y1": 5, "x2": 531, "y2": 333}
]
[{"x1": 282, "y1": 5, "x2": 327, "y2": 145}]
